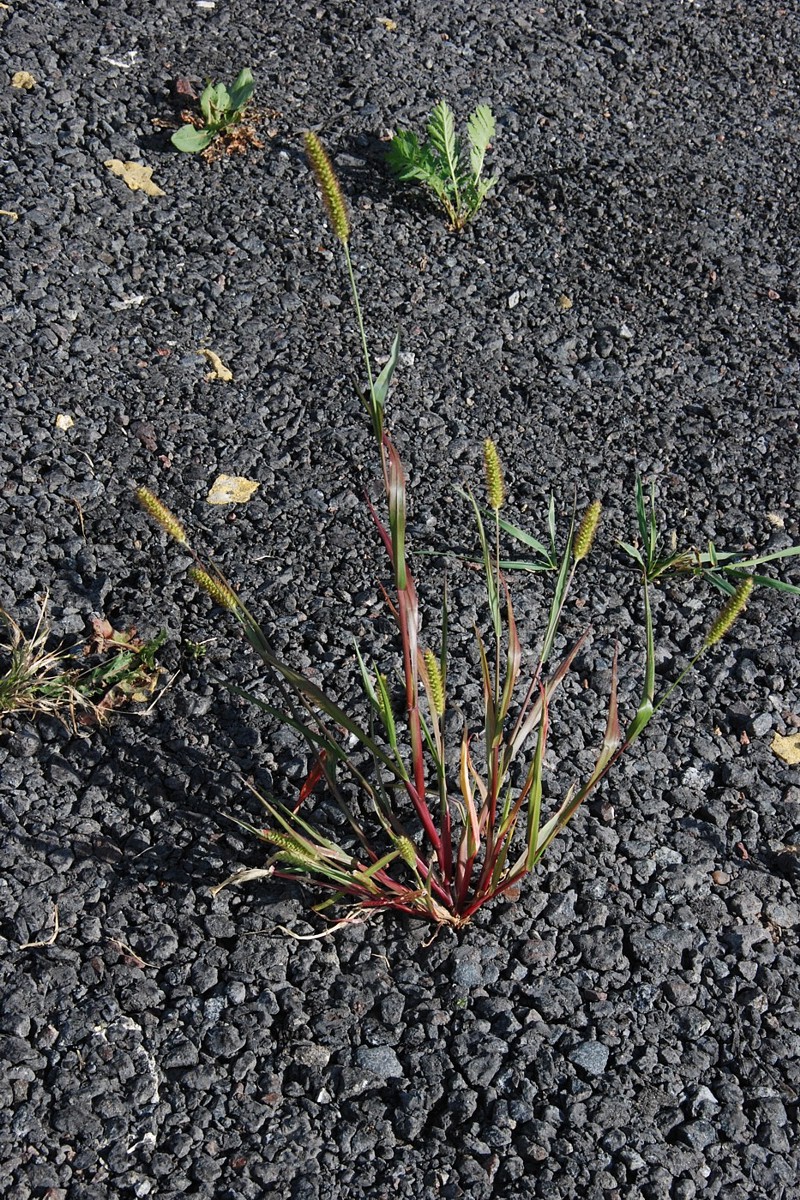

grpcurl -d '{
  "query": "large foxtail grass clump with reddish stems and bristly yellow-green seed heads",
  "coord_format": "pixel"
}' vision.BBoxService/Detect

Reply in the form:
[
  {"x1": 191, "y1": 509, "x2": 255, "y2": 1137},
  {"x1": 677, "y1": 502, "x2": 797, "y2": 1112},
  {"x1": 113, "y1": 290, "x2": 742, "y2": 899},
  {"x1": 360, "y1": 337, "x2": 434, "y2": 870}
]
[{"x1": 137, "y1": 133, "x2": 800, "y2": 928}]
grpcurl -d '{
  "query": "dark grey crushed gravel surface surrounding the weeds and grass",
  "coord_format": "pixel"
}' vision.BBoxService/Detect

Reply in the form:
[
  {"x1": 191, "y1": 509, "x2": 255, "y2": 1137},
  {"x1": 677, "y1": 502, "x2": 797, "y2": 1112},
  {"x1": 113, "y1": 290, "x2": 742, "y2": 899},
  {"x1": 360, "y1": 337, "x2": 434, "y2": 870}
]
[{"x1": 0, "y1": 0, "x2": 800, "y2": 1200}]
